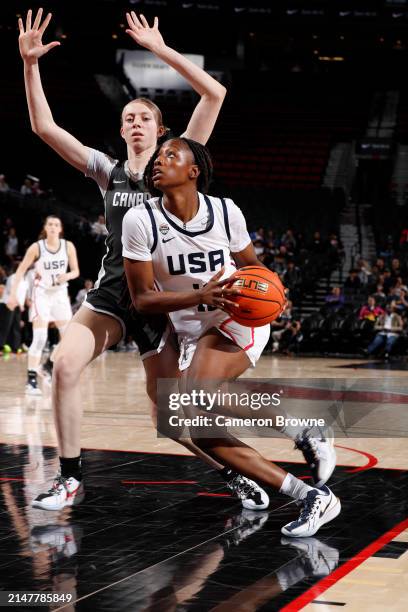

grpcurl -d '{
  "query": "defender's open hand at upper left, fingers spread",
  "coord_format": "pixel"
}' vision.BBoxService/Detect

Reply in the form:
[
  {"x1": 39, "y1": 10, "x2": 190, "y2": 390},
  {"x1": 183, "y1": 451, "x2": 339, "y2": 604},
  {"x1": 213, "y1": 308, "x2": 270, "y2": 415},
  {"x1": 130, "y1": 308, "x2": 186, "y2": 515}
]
[{"x1": 18, "y1": 8, "x2": 61, "y2": 64}]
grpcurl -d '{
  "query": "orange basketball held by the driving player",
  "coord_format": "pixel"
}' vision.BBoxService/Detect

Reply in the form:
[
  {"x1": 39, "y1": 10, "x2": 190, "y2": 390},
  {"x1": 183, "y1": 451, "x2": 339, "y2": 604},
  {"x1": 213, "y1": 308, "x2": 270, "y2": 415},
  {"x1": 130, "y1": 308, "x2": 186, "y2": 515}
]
[{"x1": 228, "y1": 266, "x2": 286, "y2": 327}]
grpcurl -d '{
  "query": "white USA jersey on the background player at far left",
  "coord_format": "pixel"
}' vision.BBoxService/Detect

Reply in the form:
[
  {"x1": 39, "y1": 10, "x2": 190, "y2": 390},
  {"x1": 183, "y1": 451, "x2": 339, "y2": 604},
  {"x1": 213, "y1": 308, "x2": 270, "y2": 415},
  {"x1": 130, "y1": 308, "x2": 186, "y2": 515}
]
[{"x1": 34, "y1": 238, "x2": 68, "y2": 290}]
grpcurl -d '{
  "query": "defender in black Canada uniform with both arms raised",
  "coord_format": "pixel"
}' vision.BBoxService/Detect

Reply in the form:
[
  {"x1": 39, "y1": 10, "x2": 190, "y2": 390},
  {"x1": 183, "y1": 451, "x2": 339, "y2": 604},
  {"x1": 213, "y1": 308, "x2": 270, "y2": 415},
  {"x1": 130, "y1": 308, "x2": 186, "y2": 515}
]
[{"x1": 18, "y1": 9, "x2": 268, "y2": 510}]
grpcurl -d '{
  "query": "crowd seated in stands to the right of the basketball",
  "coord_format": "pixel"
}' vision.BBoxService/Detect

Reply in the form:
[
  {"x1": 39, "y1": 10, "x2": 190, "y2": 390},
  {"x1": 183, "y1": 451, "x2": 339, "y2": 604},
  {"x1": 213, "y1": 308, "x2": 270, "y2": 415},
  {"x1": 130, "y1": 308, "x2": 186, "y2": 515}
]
[{"x1": 251, "y1": 228, "x2": 408, "y2": 359}]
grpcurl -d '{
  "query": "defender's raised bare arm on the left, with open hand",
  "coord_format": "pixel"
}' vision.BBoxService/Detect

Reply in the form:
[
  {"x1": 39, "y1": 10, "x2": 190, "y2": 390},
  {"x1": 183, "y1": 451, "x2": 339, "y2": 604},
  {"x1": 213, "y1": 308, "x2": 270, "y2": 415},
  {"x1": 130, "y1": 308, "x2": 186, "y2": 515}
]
[{"x1": 18, "y1": 8, "x2": 89, "y2": 173}]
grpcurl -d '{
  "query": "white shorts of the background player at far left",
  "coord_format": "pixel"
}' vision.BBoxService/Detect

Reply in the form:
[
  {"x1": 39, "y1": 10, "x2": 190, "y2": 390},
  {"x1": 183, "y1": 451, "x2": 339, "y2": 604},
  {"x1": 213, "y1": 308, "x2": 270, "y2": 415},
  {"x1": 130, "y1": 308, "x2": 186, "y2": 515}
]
[{"x1": 30, "y1": 287, "x2": 72, "y2": 323}]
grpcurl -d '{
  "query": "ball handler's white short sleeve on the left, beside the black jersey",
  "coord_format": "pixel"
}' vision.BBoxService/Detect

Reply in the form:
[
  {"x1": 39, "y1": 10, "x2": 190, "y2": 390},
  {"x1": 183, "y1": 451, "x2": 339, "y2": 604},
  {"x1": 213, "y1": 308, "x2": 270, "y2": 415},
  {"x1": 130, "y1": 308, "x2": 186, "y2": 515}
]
[{"x1": 122, "y1": 208, "x2": 153, "y2": 261}]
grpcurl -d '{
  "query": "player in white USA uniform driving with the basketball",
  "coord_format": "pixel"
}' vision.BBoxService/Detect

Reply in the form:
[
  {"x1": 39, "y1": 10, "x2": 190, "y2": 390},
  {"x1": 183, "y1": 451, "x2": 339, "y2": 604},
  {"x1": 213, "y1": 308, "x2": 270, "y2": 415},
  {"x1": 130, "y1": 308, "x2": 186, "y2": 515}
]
[{"x1": 122, "y1": 138, "x2": 341, "y2": 537}]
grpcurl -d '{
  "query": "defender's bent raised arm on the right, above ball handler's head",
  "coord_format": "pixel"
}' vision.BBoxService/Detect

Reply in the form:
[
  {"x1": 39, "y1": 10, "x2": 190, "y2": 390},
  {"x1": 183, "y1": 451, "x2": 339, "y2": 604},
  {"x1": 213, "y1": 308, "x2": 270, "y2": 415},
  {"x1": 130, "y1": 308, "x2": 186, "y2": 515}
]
[{"x1": 126, "y1": 11, "x2": 227, "y2": 144}]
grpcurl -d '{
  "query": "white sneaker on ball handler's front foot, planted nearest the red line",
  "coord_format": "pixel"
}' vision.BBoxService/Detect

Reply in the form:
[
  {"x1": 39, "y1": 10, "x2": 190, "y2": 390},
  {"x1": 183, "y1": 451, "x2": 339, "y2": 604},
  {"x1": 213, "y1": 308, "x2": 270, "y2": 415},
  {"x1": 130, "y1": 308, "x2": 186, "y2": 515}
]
[{"x1": 281, "y1": 486, "x2": 341, "y2": 538}]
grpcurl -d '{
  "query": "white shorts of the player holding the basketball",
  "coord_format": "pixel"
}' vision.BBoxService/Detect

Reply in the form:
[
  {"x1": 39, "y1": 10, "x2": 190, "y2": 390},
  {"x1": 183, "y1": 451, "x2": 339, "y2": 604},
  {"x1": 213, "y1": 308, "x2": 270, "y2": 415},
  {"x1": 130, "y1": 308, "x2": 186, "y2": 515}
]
[{"x1": 177, "y1": 311, "x2": 271, "y2": 370}]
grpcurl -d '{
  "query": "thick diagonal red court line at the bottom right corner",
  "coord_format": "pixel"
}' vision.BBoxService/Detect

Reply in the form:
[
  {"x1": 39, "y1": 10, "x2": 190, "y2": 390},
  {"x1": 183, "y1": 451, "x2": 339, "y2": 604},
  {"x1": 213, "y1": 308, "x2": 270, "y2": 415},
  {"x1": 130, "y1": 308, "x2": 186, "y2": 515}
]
[{"x1": 280, "y1": 519, "x2": 408, "y2": 612}]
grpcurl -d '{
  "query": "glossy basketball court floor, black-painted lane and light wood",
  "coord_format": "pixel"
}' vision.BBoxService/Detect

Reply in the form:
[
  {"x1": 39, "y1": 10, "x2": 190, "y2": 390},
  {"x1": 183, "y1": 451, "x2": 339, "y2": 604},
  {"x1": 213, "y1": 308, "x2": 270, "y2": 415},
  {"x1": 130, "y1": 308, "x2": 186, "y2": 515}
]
[{"x1": 0, "y1": 353, "x2": 408, "y2": 612}]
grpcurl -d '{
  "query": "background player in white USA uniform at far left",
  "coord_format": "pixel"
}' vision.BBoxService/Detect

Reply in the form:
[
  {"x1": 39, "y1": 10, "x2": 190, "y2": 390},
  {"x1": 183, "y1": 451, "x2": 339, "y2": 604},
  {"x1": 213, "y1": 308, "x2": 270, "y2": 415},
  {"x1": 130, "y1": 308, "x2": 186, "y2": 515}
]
[{"x1": 8, "y1": 215, "x2": 79, "y2": 395}]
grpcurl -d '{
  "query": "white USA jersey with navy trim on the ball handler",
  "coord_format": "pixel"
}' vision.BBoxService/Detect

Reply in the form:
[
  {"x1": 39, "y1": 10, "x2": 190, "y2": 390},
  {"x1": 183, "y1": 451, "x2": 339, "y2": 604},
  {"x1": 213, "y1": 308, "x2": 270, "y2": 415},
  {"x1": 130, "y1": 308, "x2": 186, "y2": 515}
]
[{"x1": 122, "y1": 193, "x2": 251, "y2": 338}]
